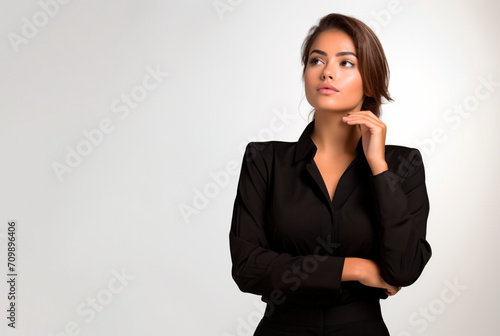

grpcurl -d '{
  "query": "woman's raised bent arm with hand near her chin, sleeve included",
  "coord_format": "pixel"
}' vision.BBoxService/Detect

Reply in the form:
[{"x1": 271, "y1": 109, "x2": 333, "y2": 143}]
[{"x1": 343, "y1": 111, "x2": 432, "y2": 286}]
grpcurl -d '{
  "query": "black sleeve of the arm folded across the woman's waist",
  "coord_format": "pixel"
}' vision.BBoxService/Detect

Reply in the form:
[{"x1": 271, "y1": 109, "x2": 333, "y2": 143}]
[{"x1": 229, "y1": 142, "x2": 344, "y2": 298}]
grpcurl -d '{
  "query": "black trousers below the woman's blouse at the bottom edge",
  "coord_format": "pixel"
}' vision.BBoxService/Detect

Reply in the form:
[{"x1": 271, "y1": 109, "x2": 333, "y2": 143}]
[{"x1": 254, "y1": 300, "x2": 389, "y2": 336}]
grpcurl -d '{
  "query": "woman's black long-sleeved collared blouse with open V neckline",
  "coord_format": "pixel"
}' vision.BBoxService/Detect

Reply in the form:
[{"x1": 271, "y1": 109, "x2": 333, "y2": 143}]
[{"x1": 229, "y1": 120, "x2": 431, "y2": 307}]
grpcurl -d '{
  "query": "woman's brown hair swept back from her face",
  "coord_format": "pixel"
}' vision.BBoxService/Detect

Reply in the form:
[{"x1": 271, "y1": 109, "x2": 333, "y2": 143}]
[{"x1": 302, "y1": 13, "x2": 393, "y2": 120}]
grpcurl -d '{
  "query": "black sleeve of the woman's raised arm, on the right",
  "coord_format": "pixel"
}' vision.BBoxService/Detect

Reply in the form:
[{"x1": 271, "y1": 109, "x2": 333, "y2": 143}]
[{"x1": 370, "y1": 148, "x2": 432, "y2": 286}]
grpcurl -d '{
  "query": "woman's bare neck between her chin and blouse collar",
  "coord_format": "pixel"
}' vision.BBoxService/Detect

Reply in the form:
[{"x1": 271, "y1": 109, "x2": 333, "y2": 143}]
[{"x1": 311, "y1": 110, "x2": 361, "y2": 156}]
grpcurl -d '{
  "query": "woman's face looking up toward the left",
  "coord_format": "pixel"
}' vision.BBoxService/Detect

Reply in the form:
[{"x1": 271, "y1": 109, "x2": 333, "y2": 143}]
[{"x1": 304, "y1": 30, "x2": 364, "y2": 112}]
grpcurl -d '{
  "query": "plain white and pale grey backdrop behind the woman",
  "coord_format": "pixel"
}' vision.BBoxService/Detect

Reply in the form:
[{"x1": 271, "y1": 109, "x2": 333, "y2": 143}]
[{"x1": 0, "y1": 0, "x2": 500, "y2": 336}]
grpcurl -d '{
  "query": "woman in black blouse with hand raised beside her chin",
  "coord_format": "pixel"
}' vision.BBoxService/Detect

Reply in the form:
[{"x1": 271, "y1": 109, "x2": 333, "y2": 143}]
[{"x1": 229, "y1": 14, "x2": 431, "y2": 336}]
